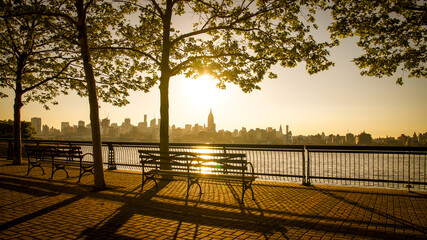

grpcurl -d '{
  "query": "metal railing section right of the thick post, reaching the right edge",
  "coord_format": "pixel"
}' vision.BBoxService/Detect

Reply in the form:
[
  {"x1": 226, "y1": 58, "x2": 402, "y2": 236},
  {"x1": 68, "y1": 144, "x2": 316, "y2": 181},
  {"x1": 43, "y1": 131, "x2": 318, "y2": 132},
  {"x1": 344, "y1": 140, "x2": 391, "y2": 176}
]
[{"x1": 306, "y1": 146, "x2": 427, "y2": 190}]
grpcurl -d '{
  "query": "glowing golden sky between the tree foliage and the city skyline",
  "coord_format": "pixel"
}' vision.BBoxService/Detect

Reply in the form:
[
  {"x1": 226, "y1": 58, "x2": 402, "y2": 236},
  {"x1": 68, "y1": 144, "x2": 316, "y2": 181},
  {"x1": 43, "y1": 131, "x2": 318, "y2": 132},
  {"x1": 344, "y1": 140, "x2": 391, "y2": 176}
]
[{"x1": 0, "y1": 7, "x2": 427, "y2": 137}]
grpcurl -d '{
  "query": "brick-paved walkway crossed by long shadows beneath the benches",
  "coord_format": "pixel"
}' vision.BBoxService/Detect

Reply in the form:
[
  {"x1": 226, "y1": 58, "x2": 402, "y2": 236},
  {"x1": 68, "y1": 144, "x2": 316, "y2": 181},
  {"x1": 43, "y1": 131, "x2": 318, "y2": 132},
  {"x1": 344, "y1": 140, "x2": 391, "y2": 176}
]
[{"x1": 0, "y1": 160, "x2": 427, "y2": 239}]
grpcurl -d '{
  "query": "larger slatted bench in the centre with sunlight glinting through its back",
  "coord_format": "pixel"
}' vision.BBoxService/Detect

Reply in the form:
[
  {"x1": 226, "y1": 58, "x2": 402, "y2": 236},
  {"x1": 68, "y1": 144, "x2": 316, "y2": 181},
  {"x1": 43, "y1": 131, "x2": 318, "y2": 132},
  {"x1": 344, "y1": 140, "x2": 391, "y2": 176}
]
[{"x1": 138, "y1": 150, "x2": 256, "y2": 204}]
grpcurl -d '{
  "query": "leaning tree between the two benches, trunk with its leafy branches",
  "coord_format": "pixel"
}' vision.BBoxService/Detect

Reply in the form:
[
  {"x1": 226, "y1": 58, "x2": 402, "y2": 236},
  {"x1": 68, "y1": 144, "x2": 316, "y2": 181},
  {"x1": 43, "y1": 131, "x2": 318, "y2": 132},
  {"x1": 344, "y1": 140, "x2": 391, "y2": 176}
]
[{"x1": 2, "y1": 0, "x2": 145, "y2": 189}]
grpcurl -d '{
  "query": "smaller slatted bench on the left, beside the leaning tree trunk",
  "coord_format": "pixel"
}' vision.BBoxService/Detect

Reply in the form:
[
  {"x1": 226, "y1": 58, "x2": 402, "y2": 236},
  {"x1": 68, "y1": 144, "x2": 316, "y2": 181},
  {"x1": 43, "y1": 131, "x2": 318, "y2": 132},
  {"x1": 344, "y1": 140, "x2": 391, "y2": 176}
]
[{"x1": 24, "y1": 145, "x2": 93, "y2": 182}]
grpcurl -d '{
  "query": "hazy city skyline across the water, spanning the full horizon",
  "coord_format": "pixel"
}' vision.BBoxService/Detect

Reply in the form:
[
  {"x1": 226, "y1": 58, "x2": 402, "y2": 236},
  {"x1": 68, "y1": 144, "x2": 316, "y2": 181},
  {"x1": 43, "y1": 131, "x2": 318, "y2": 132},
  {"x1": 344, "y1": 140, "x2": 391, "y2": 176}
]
[{"x1": 26, "y1": 110, "x2": 427, "y2": 146}]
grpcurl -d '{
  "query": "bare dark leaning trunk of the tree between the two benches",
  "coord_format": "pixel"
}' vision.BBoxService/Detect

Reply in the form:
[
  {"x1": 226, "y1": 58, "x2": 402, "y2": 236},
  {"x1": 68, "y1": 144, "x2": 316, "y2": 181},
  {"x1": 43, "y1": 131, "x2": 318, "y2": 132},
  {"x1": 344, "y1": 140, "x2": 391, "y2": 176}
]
[{"x1": 75, "y1": 0, "x2": 105, "y2": 190}]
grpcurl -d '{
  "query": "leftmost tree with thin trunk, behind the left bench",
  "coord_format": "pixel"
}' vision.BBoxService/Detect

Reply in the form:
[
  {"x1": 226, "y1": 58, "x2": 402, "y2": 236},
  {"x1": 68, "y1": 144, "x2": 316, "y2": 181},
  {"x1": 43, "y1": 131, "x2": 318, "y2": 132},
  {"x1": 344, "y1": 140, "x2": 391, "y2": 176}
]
[{"x1": 0, "y1": 1, "x2": 79, "y2": 164}]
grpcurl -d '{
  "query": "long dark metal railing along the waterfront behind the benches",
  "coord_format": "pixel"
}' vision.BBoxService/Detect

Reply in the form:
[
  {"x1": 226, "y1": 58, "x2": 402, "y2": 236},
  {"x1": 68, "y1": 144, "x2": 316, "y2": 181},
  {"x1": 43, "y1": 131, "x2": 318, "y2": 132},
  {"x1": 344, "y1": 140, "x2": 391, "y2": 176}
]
[{"x1": 0, "y1": 139, "x2": 427, "y2": 190}]
